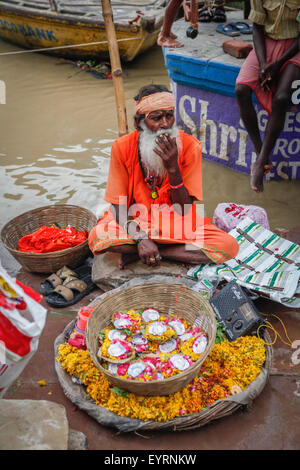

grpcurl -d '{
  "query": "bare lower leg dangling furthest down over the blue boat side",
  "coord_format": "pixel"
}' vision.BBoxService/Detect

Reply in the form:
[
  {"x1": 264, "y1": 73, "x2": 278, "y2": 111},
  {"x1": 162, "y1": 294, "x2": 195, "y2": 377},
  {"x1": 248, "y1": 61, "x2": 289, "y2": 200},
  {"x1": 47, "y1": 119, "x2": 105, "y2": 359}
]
[{"x1": 251, "y1": 64, "x2": 300, "y2": 192}]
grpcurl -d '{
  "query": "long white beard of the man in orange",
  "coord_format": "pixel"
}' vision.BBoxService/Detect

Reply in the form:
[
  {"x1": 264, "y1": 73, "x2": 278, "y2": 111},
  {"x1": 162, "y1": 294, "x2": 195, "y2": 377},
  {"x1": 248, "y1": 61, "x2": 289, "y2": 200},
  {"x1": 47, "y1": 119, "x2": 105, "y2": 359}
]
[{"x1": 139, "y1": 120, "x2": 181, "y2": 179}]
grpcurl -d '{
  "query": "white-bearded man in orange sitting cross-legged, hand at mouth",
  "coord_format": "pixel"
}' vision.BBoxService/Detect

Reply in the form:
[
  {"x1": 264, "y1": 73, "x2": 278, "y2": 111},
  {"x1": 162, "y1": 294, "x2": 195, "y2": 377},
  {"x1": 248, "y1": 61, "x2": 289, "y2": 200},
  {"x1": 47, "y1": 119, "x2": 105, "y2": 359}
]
[{"x1": 89, "y1": 84, "x2": 238, "y2": 269}]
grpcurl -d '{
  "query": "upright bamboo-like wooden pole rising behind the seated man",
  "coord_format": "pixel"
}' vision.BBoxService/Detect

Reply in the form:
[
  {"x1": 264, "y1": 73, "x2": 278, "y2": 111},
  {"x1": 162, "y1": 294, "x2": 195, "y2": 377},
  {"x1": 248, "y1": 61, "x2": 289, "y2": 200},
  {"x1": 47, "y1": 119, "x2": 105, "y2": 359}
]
[{"x1": 101, "y1": 0, "x2": 128, "y2": 136}]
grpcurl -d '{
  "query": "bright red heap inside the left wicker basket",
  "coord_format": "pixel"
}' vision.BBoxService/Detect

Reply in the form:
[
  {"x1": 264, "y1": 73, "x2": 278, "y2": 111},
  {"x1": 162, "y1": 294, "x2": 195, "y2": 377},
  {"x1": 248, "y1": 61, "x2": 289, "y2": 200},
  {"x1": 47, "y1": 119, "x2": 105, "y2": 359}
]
[{"x1": 18, "y1": 225, "x2": 88, "y2": 253}]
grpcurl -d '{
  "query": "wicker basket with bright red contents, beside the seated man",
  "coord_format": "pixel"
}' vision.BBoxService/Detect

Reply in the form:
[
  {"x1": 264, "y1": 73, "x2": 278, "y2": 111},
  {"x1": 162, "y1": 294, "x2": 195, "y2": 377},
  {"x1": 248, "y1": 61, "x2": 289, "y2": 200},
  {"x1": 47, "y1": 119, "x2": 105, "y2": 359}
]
[{"x1": 1, "y1": 204, "x2": 97, "y2": 273}]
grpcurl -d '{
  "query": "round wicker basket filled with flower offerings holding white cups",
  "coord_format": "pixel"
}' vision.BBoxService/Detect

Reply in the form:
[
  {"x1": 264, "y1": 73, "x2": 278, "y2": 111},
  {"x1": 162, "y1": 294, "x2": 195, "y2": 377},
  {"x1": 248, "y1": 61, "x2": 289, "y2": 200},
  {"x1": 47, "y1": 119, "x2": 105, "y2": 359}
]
[{"x1": 86, "y1": 282, "x2": 217, "y2": 396}]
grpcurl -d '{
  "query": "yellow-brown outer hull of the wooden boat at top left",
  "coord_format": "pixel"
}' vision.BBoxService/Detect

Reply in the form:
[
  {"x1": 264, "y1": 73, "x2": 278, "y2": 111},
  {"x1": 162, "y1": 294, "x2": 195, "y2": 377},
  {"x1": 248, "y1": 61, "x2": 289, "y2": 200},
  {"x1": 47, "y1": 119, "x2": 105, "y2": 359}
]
[{"x1": 0, "y1": 6, "x2": 161, "y2": 62}]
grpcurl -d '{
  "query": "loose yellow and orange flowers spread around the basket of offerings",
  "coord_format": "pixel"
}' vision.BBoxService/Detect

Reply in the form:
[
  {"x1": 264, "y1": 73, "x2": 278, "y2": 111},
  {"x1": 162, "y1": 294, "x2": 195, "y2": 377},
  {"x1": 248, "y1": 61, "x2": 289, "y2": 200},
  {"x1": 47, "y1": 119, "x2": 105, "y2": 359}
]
[{"x1": 57, "y1": 336, "x2": 266, "y2": 422}]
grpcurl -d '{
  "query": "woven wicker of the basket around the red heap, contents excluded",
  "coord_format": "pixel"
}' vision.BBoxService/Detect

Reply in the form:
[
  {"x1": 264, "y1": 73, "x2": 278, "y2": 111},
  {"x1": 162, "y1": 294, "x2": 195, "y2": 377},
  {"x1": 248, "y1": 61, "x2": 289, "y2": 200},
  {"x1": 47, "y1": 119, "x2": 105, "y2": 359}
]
[{"x1": 1, "y1": 204, "x2": 97, "y2": 273}]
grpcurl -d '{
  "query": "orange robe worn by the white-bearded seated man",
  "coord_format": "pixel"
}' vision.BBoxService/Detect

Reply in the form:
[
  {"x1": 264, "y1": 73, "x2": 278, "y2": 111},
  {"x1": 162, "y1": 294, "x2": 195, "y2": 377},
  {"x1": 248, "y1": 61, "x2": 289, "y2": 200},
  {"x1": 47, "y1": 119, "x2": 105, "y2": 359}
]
[{"x1": 89, "y1": 131, "x2": 238, "y2": 264}]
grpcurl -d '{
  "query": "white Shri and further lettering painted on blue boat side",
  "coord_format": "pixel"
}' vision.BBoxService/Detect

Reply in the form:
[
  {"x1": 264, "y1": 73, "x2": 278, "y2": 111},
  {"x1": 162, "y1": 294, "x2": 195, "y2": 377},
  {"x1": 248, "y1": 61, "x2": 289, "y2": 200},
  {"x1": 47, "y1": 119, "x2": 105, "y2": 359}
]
[{"x1": 178, "y1": 90, "x2": 300, "y2": 179}]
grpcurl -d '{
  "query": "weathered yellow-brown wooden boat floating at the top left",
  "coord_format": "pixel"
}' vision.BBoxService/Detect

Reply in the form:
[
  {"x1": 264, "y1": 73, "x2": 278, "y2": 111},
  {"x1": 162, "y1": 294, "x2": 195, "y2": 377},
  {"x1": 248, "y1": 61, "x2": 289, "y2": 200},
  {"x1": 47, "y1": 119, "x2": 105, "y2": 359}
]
[{"x1": 0, "y1": 0, "x2": 166, "y2": 62}]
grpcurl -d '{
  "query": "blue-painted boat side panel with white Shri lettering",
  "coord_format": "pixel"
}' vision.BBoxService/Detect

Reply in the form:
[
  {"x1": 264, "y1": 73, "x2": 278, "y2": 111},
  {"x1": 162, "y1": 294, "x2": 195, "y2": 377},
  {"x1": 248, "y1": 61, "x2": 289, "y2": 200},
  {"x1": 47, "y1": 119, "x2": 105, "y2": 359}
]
[{"x1": 171, "y1": 80, "x2": 300, "y2": 180}]
